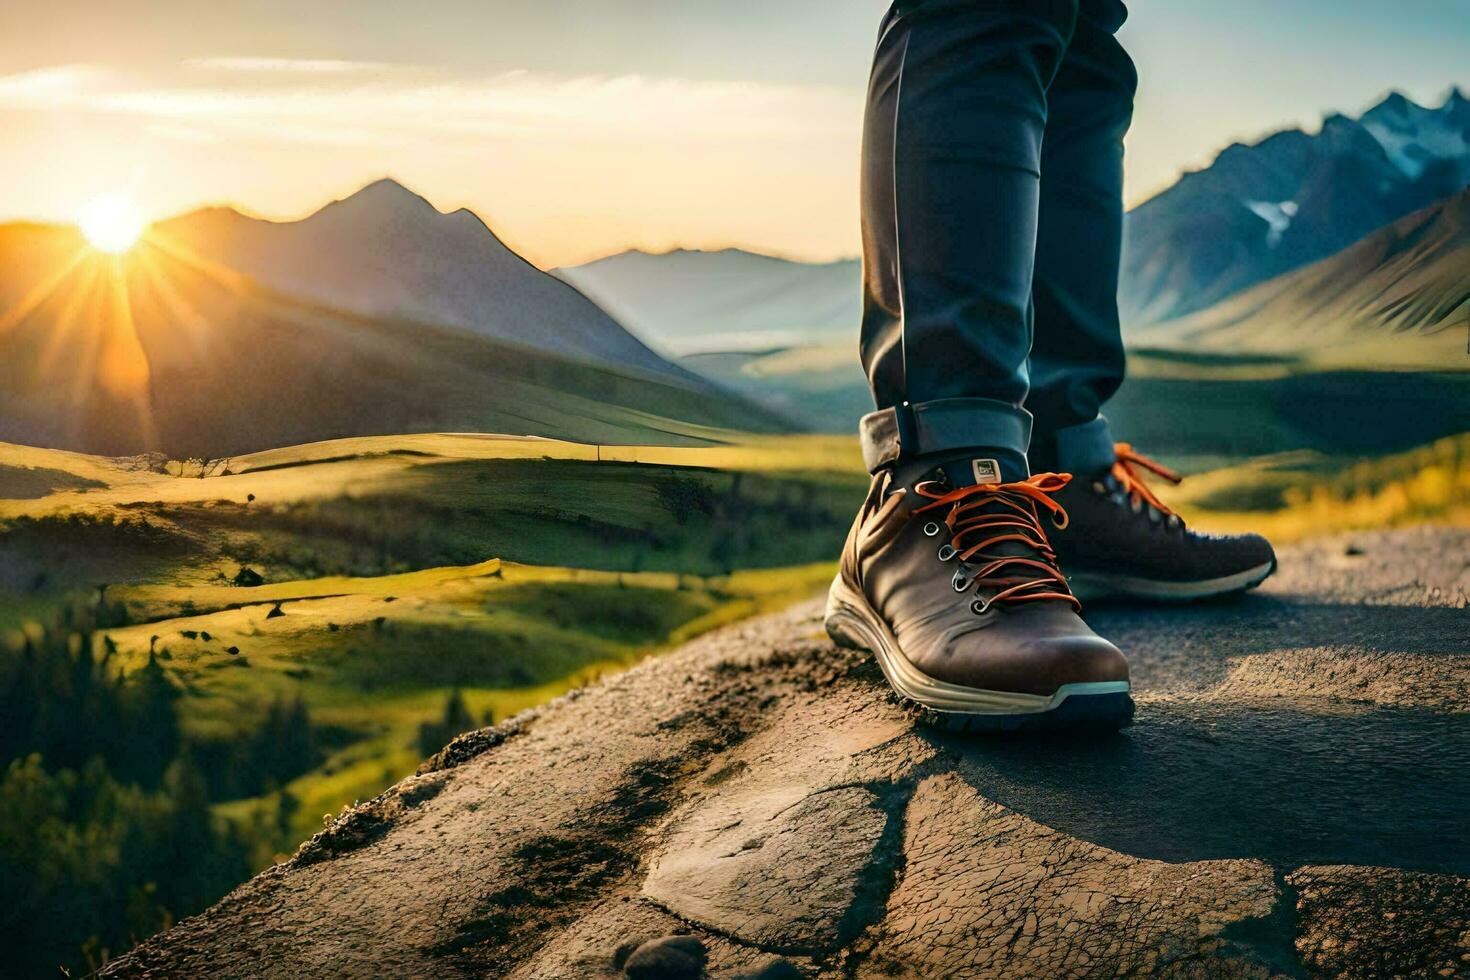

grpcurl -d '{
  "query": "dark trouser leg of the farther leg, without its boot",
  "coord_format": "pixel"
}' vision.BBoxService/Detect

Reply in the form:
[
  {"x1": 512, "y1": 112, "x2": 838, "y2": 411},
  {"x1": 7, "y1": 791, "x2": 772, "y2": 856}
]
[{"x1": 1026, "y1": 0, "x2": 1138, "y2": 476}]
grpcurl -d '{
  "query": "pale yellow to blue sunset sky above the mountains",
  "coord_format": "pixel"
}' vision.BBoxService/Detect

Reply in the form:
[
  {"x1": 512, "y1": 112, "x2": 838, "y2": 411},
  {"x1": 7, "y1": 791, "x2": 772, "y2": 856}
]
[{"x1": 0, "y1": 0, "x2": 1470, "y2": 267}]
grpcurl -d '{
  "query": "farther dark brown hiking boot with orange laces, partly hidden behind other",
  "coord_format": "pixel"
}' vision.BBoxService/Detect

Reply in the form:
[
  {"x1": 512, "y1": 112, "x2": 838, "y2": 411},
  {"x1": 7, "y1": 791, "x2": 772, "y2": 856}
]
[{"x1": 1051, "y1": 442, "x2": 1276, "y2": 601}]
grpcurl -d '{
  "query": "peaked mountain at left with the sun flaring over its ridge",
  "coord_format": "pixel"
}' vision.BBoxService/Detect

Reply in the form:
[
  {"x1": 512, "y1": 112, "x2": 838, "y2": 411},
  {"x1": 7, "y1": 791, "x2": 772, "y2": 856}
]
[{"x1": 0, "y1": 192, "x2": 789, "y2": 458}]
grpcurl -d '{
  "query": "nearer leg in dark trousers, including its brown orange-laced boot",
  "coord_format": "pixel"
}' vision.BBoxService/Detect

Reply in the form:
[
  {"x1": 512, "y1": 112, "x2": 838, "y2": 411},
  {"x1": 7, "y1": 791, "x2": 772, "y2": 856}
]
[{"x1": 826, "y1": 0, "x2": 1133, "y2": 730}]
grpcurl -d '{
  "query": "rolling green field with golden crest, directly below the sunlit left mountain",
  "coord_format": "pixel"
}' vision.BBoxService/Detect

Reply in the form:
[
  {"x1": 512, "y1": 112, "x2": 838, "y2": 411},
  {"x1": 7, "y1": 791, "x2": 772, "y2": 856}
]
[{"x1": 0, "y1": 435, "x2": 864, "y2": 590}]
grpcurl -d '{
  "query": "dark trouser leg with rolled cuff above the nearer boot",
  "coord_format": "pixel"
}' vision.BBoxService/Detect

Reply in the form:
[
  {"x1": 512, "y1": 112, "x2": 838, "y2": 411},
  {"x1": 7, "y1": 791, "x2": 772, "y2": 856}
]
[{"x1": 861, "y1": 0, "x2": 1078, "y2": 479}]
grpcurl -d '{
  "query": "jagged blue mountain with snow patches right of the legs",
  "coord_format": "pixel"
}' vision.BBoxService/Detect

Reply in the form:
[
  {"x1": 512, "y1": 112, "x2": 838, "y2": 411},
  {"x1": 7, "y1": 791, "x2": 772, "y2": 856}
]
[{"x1": 1120, "y1": 88, "x2": 1470, "y2": 326}]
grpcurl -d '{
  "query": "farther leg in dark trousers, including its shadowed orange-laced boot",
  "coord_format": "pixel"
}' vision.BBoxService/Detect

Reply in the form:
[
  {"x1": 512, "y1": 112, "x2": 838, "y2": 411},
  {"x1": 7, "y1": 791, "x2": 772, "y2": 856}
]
[{"x1": 1026, "y1": 0, "x2": 1276, "y2": 599}]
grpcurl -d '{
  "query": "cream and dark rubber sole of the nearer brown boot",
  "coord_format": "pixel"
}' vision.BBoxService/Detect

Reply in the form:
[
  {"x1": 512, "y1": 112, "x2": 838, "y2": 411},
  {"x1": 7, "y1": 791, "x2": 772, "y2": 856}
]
[{"x1": 826, "y1": 576, "x2": 1133, "y2": 730}]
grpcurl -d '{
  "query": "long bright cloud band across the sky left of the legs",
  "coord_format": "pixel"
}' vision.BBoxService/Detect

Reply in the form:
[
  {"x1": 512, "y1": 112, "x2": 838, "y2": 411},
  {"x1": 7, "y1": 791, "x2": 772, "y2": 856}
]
[{"x1": 0, "y1": 59, "x2": 861, "y2": 145}]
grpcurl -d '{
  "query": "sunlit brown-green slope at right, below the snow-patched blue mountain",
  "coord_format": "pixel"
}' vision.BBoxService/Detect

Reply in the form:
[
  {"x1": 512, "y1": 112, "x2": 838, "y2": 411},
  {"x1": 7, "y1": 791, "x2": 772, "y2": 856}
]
[{"x1": 1132, "y1": 190, "x2": 1470, "y2": 369}]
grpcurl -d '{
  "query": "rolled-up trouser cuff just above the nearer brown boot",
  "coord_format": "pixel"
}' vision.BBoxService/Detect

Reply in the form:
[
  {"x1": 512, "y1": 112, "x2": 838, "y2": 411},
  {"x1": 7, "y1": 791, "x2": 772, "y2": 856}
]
[{"x1": 861, "y1": 398, "x2": 1030, "y2": 473}]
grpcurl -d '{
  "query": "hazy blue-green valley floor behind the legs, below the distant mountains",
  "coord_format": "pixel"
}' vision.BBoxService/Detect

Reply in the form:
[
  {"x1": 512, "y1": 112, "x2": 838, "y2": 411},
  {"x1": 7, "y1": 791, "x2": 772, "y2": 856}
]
[{"x1": 685, "y1": 345, "x2": 1470, "y2": 461}]
